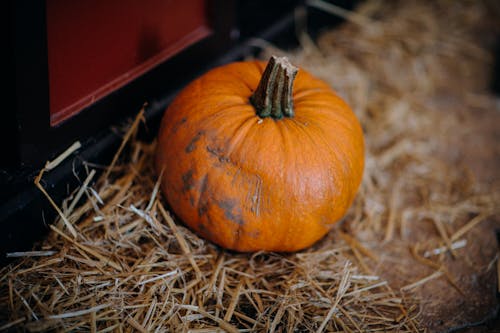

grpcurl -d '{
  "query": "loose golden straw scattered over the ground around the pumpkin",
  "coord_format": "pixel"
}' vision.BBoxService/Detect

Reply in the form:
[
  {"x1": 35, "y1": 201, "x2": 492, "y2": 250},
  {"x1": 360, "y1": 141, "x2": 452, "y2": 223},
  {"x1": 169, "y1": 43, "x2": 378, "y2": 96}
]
[{"x1": 0, "y1": 1, "x2": 500, "y2": 332}]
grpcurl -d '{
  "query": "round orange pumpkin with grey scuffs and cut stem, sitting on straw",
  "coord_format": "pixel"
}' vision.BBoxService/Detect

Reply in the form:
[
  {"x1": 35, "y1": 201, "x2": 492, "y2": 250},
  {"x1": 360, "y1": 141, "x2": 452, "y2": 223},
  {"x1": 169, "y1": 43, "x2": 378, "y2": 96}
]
[{"x1": 156, "y1": 57, "x2": 364, "y2": 252}]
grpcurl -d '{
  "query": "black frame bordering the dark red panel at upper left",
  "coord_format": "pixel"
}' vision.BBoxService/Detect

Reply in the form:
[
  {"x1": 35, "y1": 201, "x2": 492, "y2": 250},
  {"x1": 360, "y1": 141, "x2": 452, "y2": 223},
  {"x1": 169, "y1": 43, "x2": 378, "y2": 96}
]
[{"x1": 5, "y1": 0, "x2": 234, "y2": 168}]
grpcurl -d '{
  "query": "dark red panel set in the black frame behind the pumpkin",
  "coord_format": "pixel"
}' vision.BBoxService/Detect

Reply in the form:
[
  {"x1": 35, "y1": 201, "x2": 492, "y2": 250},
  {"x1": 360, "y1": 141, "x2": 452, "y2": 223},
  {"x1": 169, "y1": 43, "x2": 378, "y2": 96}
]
[{"x1": 46, "y1": 0, "x2": 211, "y2": 125}]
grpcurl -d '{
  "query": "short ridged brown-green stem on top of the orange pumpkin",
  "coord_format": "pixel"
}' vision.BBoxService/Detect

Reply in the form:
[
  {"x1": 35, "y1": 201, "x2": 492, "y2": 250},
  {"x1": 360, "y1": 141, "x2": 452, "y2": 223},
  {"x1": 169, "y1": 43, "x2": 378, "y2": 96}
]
[{"x1": 250, "y1": 56, "x2": 298, "y2": 119}]
